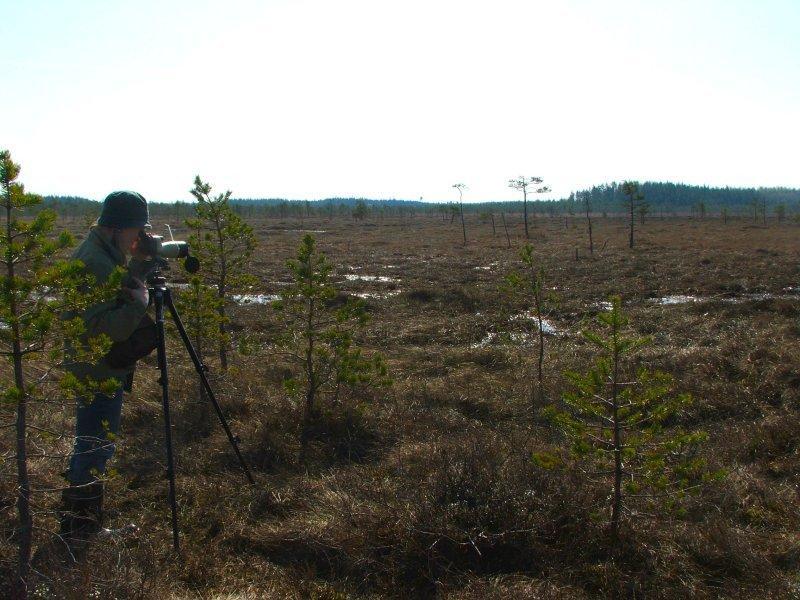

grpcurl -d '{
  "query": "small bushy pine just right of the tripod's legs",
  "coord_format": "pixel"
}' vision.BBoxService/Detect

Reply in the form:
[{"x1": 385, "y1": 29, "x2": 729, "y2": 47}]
[{"x1": 273, "y1": 235, "x2": 387, "y2": 460}]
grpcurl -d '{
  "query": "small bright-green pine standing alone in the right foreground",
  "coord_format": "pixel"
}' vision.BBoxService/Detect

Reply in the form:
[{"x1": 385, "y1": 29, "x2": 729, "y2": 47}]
[{"x1": 545, "y1": 297, "x2": 721, "y2": 543}]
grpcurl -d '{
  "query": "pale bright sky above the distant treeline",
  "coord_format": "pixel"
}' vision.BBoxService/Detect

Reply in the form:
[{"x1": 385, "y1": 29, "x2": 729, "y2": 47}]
[{"x1": 0, "y1": 0, "x2": 800, "y2": 201}]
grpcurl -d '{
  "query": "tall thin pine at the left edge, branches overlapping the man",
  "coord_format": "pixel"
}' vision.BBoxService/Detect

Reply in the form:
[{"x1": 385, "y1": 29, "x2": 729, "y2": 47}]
[{"x1": 0, "y1": 150, "x2": 115, "y2": 598}]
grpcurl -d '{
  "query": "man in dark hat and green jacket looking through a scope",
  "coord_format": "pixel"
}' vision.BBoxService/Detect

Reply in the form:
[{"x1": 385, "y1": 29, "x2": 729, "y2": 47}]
[{"x1": 59, "y1": 192, "x2": 156, "y2": 546}]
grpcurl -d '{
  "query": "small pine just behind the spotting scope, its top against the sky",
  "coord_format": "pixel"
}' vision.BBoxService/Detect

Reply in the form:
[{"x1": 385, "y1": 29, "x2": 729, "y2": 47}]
[{"x1": 186, "y1": 176, "x2": 256, "y2": 370}]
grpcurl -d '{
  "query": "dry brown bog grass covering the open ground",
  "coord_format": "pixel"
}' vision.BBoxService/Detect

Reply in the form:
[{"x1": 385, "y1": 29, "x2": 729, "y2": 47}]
[{"x1": 2, "y1": 217, "x2": 800, "y2": 599}]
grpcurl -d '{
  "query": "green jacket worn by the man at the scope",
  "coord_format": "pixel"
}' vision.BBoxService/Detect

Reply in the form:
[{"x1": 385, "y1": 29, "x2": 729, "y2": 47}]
[{"x1": 64, "y1": 227, "x2": 152, "y2": 391}]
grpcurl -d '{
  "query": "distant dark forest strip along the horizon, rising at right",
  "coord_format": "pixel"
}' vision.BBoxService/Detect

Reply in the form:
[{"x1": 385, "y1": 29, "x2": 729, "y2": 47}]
[{"x1": 44, "y1": 182, "x2": 800, "y2": 219}]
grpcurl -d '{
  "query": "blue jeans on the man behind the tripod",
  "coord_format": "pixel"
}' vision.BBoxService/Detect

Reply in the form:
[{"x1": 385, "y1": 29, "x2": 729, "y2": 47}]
[{"x1": 67, "y1": 388, "x2": 122, "y2": 485}]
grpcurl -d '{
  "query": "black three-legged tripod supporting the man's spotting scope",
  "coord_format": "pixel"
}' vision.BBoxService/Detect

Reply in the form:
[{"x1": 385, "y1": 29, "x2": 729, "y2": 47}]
[{"x1": 148, "y1": 270, "x2": 255, "y2": 552}]
